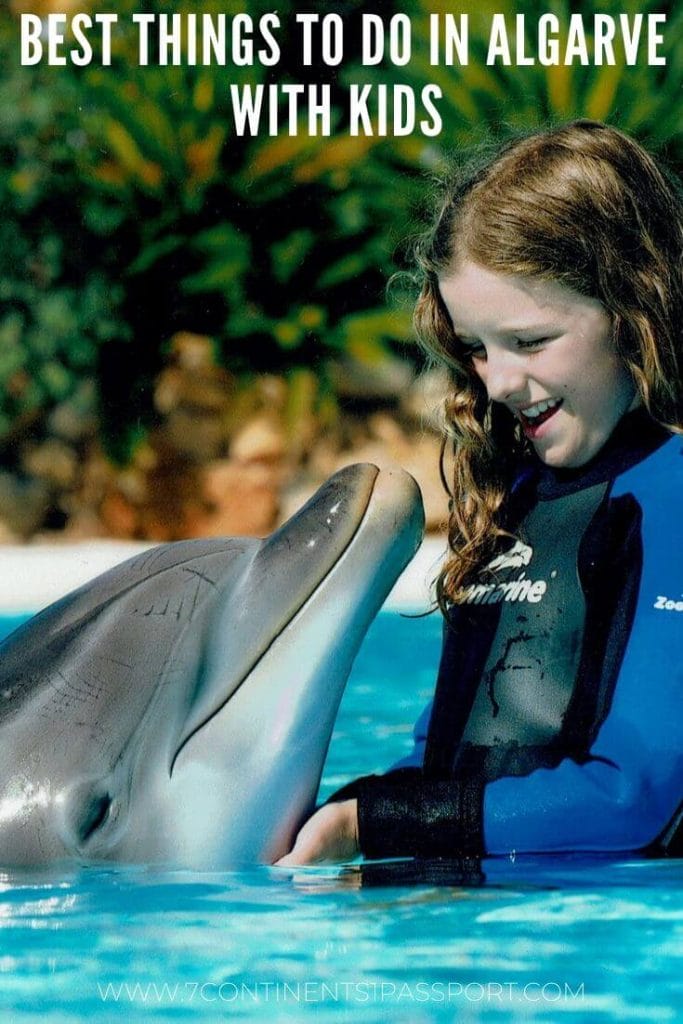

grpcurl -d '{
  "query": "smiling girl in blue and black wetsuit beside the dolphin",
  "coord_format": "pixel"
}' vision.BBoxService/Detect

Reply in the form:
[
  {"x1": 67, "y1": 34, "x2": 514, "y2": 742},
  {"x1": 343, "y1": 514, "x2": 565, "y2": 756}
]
[{"x1": 280, "y1": 121, "x2": 683, "y2": 864}]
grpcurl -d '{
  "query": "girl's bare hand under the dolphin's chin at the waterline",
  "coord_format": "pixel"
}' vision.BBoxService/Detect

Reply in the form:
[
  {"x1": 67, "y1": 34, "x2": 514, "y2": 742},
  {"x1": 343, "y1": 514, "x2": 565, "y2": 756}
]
[{"x1": 275, "y1": 800, "x2": 360, "y2": 867}]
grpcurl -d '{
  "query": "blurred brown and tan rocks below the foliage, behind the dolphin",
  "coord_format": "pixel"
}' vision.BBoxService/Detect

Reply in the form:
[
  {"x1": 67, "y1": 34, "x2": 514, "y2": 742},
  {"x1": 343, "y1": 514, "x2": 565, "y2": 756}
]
[{"x1": 0, "y1": 334, "x2": 446, "y2": 542}]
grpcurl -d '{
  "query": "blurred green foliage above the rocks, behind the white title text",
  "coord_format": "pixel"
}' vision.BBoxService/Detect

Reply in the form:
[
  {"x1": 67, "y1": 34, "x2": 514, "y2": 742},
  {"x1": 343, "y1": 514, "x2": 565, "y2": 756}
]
[{"x1": 0, "y1": 0, "x2": 683, "y2": 458}]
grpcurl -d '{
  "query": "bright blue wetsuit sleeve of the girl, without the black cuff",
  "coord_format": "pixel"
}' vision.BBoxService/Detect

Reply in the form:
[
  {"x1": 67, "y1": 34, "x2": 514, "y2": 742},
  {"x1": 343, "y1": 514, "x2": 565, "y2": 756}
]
[{"x1": 482, "y1": 471, "x2": 683, "y2": 854}]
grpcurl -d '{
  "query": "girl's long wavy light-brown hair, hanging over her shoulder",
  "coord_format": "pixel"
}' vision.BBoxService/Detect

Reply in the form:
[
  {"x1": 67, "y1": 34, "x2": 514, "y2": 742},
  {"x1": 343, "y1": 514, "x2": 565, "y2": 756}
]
[{"x1": 415, "y1": 121, "x2": 683, "y2": 610}]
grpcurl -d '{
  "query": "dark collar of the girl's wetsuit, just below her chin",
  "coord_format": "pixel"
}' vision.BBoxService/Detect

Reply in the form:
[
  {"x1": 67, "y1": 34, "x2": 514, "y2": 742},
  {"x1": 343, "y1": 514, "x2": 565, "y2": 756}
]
[{"x1": 532, "y1": 407, "x2": 672, "y2": 499}]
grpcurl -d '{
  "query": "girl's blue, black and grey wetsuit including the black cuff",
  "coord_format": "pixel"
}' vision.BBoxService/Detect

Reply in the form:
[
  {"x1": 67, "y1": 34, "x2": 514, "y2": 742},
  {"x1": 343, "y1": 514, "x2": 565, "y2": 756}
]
[{"x1": 333, "y1": 411, "x2": 683, "y2": 857}]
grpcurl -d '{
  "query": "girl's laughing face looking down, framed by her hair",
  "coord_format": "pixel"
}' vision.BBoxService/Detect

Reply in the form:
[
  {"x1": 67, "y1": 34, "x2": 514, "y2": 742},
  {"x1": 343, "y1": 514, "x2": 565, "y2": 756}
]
[{"x1": 439, "y1": 261, "x2": 638, "y2": 468}]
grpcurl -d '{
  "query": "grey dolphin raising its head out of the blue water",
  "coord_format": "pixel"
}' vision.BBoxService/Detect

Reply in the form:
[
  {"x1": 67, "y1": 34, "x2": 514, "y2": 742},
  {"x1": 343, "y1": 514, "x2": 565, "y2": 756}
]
[{"x1": 0, "y1": 465, "x2": 424, "y2": 870}]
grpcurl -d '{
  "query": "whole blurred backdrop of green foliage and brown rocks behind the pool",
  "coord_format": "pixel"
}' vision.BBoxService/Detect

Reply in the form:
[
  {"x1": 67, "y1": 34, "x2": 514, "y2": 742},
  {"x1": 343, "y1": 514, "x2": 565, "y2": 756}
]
[{"x1": 0, "y1": 0, "x2": 683, "y2": 543}]
